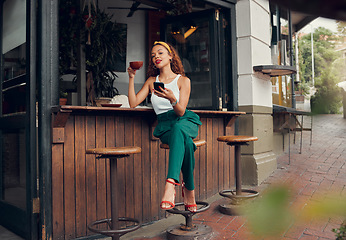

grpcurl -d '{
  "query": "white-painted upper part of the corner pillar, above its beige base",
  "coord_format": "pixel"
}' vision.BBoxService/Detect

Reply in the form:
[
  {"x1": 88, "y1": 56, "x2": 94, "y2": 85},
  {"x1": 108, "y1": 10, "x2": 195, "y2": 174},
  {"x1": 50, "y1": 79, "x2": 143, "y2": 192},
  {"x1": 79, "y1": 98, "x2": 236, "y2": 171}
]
[{"x1": 236, "y1": 0, "x2": 272, "y2": 107}]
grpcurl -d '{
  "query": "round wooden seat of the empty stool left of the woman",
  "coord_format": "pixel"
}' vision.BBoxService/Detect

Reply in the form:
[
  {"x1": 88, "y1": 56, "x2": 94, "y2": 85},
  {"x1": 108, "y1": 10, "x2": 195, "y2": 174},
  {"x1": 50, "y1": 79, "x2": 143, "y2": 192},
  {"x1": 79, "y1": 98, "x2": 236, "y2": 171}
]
[{"x1": 85, "y1": 147, "x2": 141, "y2": 157}]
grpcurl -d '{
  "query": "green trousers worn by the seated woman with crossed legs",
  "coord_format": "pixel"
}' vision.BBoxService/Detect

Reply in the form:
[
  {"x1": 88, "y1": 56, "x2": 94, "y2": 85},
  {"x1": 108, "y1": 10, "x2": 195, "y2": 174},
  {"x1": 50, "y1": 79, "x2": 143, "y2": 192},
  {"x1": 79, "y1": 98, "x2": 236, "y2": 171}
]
[{"x1": 154, "y1": 110, "x2": 202, "y2": 190}]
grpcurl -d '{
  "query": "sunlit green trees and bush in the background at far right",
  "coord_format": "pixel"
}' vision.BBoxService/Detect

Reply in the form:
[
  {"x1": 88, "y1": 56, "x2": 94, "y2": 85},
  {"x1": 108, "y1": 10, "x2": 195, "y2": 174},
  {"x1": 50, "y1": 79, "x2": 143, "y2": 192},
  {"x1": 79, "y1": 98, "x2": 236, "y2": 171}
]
[{"x1": 299, "y1": 27, "x2": 345, "y2": 114}]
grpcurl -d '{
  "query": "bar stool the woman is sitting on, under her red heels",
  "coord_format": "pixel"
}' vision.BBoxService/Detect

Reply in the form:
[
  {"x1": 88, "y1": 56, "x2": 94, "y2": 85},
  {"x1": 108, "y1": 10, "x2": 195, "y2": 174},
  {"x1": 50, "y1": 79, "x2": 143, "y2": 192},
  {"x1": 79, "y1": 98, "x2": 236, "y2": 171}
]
[{"x1": 160, "y1": 139, "x2": 212, "y2": 240}]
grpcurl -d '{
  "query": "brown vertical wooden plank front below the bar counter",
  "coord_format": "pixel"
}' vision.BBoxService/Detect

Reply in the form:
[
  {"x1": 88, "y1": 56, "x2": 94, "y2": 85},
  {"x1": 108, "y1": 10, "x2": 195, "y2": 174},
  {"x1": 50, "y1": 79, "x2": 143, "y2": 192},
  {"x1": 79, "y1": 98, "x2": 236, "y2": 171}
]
[{"x1": 52, "y1": 114, "x2": 234, "y2": 239}]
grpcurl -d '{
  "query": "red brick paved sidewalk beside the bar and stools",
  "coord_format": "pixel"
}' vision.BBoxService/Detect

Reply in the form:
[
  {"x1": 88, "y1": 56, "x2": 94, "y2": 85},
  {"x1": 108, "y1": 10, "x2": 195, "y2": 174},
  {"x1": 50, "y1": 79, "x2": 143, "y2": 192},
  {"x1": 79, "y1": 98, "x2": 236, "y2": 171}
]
[{"x1": 127, "y1": 115, "x2": 346, "y2": 240}]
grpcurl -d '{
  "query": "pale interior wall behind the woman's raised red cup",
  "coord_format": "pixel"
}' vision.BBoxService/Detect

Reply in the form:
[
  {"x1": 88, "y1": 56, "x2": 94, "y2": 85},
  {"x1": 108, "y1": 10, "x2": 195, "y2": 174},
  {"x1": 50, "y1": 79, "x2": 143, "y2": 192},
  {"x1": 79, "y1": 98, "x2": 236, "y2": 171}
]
[{"x1": 99, "y1": 0, "x2": 148, "y2": 95}]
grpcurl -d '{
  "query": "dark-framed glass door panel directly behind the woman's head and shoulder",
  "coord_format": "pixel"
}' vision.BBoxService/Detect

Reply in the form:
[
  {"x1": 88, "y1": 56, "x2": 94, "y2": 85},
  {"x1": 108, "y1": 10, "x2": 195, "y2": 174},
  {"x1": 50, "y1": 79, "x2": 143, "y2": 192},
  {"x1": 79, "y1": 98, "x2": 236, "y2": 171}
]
[{"x1": 161, "y1": 9, "x2": 232, "y2": 110}]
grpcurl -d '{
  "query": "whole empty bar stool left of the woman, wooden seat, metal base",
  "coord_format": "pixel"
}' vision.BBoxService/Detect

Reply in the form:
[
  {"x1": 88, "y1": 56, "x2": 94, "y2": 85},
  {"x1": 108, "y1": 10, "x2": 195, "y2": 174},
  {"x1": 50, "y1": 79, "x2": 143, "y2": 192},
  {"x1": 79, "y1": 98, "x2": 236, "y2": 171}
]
[{"x1": 86, "y1": 146, "x2": 141, "y2": 240}]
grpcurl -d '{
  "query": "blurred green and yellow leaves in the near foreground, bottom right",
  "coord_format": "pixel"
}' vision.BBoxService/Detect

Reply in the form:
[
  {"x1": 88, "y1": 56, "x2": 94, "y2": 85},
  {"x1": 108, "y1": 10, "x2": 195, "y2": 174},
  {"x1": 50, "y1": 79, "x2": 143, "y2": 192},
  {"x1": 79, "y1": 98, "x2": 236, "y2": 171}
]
[{"x1": 244, "y1": 185, "x2": 346, "y2": 240}]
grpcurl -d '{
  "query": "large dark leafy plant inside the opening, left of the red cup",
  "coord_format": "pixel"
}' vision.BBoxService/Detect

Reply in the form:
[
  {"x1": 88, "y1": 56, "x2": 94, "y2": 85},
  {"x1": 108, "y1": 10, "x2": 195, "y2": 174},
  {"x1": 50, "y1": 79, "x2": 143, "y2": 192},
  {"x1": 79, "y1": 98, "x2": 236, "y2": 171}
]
[{"x1": 83, "y1": 5, "x2": 124, "y2": 105}]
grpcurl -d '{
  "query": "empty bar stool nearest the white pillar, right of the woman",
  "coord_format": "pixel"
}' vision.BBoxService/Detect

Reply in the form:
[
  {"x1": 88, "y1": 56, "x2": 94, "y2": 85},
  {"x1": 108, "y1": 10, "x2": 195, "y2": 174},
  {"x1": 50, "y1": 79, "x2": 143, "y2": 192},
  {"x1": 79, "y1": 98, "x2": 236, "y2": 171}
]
[{"x1": 217, "y1": 135, "x2": 259, "y2": 215}]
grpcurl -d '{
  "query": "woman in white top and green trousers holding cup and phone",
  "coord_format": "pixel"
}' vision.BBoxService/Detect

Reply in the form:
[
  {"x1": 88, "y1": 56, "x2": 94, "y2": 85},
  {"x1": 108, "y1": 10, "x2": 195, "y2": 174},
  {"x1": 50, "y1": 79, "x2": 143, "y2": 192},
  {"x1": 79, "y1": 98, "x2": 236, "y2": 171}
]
[{"x1": 127, "y1": 42, "x2": 202, "y2": 212}]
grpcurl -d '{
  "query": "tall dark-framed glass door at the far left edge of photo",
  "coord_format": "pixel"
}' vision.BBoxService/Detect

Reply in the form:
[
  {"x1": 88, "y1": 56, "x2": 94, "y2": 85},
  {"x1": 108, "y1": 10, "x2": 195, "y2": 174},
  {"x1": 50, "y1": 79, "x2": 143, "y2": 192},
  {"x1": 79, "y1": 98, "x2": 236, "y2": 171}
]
[{"x1": 0, "y1": 0, "x2": 38, "y2": 239}]
